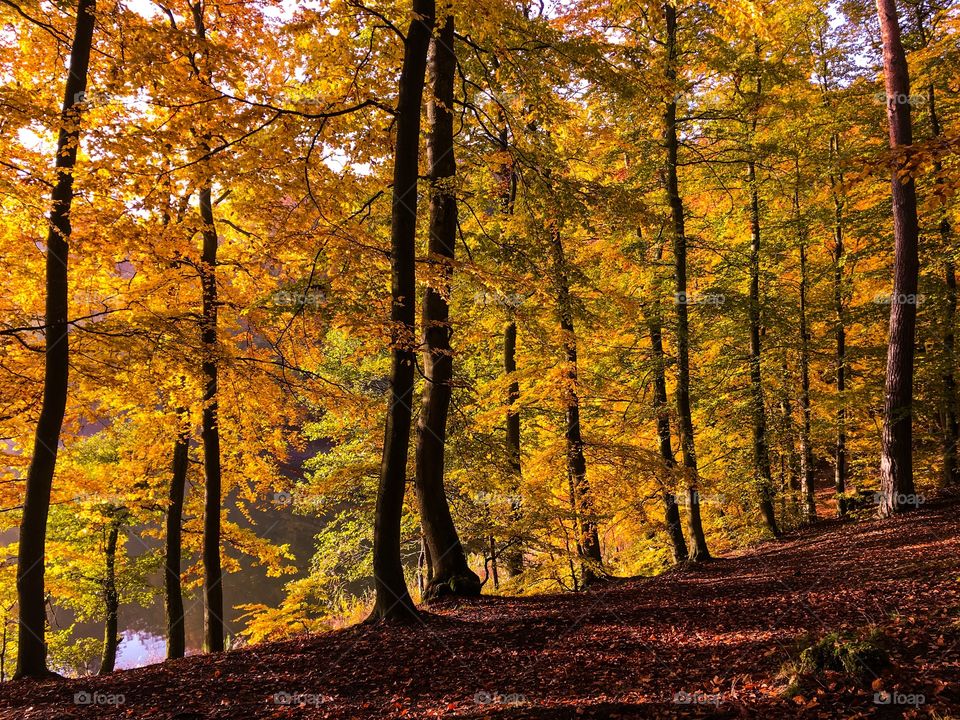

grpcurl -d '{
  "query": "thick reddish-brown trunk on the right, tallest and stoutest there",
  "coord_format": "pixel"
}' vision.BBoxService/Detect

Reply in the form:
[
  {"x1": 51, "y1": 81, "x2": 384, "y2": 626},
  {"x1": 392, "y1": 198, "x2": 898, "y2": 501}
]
[{"x1": 877, "y1": 0, "x2": 919, "y2": 517}]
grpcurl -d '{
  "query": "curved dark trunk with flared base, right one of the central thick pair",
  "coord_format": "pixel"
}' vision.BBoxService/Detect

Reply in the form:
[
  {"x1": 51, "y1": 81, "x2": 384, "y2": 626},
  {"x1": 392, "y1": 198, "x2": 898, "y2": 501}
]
[{"x1": 416, "y1": 14, "x2": 480, "y2": 600}]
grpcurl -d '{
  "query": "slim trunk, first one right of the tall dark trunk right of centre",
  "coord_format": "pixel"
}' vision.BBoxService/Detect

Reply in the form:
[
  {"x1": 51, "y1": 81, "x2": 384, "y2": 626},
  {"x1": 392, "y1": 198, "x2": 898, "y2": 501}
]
[{"x1": 747, "y1": 159, "x2": 780, "y2": 537}]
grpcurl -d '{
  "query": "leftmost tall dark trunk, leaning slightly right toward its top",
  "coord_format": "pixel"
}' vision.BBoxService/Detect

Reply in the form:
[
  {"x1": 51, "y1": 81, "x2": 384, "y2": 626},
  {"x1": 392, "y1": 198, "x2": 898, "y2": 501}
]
[{"x1": 15, "y1": 0, "x2": 96, "y2": 677}]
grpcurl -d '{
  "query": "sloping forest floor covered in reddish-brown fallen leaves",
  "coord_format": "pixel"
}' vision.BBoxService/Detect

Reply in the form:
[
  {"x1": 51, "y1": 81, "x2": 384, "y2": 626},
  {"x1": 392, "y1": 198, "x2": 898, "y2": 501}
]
[{"x1": 0, "y1": 502, "x2": 960, "y2": 720}]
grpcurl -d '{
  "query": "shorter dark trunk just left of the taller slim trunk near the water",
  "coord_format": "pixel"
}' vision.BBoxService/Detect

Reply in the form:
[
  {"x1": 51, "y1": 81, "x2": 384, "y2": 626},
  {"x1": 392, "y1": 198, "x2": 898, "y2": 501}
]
[{"x1": 163, "y1": 420, "x2": 190, "y2": 659}]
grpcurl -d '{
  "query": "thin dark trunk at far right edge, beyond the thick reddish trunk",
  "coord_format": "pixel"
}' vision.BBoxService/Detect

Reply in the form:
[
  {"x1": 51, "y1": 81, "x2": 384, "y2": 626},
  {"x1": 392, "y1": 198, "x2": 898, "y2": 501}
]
[{"x1": 927, "y1": 83, "x2": 960, "y2": 486}]
